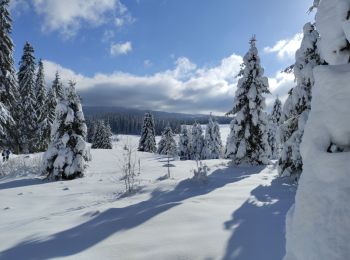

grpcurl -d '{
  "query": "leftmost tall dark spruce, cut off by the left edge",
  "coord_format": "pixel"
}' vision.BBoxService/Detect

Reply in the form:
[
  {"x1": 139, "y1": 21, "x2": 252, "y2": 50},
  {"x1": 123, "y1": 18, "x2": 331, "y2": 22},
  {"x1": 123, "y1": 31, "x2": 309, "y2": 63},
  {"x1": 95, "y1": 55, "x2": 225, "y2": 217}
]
[{"x1": 0, "y1": 0, "x2": 19, "y2": 152}]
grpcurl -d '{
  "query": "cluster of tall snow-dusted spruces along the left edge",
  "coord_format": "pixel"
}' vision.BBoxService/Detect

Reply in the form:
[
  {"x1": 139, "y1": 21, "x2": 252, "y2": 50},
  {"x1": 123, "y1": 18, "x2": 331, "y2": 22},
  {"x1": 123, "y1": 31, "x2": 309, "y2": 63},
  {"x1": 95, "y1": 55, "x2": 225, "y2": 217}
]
[{"x1": 0, "y1": 0, "x2": 90, "y2": 179}]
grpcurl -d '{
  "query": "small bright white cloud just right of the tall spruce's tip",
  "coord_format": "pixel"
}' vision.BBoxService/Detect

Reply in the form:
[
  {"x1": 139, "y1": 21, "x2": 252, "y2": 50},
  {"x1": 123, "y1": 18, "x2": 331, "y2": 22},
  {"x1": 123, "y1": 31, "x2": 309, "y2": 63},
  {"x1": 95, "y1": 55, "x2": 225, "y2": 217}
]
[{"x1": 264, "y1": 33, "x2": 303, "y2": 60}]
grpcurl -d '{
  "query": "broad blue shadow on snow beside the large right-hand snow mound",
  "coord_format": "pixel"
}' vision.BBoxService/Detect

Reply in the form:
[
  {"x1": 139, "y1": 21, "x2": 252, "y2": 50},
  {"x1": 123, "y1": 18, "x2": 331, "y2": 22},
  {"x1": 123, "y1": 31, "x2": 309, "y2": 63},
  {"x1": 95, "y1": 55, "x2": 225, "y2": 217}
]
[{"x1": 223, "y1": 176, "x2": 295, "y2": 260}]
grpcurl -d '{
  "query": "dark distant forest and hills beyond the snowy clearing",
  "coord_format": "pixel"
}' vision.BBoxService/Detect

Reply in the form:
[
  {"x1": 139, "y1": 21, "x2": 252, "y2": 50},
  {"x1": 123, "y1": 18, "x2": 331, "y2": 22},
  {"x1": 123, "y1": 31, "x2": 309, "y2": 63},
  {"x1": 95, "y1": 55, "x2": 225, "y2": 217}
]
[{"x1": 83, "y1": 107, "x2": 232, "y2": 135}]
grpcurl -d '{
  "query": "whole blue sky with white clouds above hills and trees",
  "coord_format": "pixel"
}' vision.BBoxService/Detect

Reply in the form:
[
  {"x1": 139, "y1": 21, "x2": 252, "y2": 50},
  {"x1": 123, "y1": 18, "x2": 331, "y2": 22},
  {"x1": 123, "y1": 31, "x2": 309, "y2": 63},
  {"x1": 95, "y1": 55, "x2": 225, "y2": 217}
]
[{"x1": 12, "y1": 0, "x2": 313, "y2": 113}]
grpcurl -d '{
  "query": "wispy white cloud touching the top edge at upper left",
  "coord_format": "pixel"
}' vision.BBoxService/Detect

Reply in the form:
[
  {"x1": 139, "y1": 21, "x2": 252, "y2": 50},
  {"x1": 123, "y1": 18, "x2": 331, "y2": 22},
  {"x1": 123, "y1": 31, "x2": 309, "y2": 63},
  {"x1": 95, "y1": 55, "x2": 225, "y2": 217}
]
[{"x1": 28, "y1": 0, "x2": 132, "y2": 38}]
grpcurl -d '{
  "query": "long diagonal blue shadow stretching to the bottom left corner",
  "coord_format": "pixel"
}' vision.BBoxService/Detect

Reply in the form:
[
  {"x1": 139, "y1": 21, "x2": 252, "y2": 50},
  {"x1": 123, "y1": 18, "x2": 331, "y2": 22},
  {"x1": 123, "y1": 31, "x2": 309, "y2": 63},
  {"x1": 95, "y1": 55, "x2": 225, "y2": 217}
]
[{"x1": 0, "y1": 167, "x2": 263, "y2": 260}]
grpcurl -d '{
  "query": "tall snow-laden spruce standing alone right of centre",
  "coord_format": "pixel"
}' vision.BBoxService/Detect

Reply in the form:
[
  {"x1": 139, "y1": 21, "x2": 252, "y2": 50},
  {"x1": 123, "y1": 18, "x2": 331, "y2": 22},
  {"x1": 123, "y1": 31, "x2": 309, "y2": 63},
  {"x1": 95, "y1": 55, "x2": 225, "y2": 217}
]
[{"x1": 225, "y1": 37, "x2": 270, "y2": 165}]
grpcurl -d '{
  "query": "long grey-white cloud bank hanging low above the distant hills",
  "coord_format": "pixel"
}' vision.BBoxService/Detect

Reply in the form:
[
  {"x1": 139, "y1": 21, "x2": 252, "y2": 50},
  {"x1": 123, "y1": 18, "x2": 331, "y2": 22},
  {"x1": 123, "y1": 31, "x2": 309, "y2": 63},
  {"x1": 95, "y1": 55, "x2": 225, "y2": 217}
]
[{"x1": 44, "y1": 54, "x2": 294, "y2": 115}]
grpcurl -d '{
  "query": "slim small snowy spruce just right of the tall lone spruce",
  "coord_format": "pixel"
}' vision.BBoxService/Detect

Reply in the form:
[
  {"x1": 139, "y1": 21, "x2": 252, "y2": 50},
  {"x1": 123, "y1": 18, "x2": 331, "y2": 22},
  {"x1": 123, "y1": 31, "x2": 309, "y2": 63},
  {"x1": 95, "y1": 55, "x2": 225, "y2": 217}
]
[{"x1": 268, "y1": 98, "x2": 282, "y2": 159}]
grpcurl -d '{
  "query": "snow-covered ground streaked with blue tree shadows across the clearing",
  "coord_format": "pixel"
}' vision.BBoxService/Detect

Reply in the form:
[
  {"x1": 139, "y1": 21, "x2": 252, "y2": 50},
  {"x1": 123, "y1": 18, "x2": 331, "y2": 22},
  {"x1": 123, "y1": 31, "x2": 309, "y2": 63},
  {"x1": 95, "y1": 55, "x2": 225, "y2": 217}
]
[{"x1": 0, "y1": 126, "x2": 295, "y2": 260}]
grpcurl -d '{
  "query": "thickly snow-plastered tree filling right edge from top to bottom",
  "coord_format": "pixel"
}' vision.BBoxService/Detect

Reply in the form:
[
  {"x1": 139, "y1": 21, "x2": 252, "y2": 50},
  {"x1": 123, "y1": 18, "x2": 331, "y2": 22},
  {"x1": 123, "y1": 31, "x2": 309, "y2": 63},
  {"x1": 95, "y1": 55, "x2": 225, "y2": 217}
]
[{"x1": 284, "y1": 0, "x2": 350, "y2": 260}]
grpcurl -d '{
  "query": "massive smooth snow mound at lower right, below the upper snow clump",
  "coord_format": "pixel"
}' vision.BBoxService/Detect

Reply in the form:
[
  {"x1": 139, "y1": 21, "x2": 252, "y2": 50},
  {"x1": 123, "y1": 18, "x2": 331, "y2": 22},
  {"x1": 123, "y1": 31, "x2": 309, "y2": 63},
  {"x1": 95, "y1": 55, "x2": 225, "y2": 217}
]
[{"x1": 285, "y1": 64, "x2": 350, "y2": 260}]
